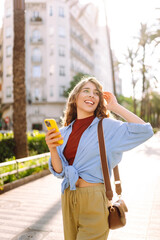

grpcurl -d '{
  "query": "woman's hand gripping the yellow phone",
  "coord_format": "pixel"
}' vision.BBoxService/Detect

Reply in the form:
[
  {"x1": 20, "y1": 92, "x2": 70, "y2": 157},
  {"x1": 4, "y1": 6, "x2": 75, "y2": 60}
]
[{"x1": 45, "y1": 129, "x2": 63, "y2": 151}]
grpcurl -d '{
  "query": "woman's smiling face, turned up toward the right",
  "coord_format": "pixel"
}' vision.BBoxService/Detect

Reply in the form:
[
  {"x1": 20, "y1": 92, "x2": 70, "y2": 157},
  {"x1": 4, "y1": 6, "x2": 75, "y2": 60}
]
[{"x1": 76, "y1": 82, "x2": 99, "y2": 119}]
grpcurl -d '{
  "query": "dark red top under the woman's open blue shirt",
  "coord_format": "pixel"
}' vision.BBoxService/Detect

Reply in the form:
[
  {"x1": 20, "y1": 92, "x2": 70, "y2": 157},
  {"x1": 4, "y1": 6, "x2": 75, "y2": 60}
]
[{"x1": 63, "y1": 116, "x2": 94, "y2": 165}]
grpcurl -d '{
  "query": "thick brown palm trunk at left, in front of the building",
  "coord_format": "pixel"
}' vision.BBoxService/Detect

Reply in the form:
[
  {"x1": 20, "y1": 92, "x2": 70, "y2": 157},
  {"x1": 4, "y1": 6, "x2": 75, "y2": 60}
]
[{"x1": 13, "y1": 0, "x2": 28, "y2": 158}]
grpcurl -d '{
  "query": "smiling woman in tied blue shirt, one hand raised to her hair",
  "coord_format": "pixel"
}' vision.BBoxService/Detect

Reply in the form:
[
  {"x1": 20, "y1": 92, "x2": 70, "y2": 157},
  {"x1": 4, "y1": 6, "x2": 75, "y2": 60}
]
[{"x1": 46, "y1": 77, "x2": 153, "y2": 240}]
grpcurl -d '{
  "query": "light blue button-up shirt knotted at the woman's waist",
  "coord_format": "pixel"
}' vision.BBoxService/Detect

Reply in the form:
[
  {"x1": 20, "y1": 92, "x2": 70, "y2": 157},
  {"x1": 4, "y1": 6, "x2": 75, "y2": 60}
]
[{"x1": 49, "y1": 117, "x2": 153, "y2": 193}]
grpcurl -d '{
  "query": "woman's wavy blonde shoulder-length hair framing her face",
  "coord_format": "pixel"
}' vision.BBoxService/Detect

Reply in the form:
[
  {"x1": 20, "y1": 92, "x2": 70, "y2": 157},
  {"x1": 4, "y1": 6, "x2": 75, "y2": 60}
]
[{"x1": 62, "y1": 77, "x2": 109, "y2": 126}]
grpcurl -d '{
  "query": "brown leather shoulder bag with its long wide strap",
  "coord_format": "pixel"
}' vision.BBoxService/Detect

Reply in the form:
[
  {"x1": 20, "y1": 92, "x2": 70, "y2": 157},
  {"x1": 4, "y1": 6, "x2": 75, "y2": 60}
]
[{"x1": 98, "y1": 119, "x2": 128, "y2": 229}]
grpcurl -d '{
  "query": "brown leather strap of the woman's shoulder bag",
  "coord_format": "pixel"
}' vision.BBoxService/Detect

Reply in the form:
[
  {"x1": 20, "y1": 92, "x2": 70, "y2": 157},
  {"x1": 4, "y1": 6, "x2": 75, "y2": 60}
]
[{"x1": 98, "y1": 119, "x2": 122, "y2": 201}]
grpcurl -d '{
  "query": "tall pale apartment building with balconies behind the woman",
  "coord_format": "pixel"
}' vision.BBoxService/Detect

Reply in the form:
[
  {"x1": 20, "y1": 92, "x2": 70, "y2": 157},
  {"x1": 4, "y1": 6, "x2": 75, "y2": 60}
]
[{"x1": 2, "y1": 0, "x2": 116, "y2": 130}]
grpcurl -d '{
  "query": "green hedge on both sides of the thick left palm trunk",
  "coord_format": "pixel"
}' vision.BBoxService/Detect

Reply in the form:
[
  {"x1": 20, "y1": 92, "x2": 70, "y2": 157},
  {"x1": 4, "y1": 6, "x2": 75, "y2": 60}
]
[{"x1": 0, "y1": 131, "x2": 49, "y2": 162}]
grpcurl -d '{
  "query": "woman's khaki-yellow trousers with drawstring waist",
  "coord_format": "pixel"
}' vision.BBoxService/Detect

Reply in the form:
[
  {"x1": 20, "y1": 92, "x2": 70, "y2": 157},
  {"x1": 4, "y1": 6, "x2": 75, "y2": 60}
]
[{"x1": 61, "y1": 184, "x2": 109, "y2": 240}]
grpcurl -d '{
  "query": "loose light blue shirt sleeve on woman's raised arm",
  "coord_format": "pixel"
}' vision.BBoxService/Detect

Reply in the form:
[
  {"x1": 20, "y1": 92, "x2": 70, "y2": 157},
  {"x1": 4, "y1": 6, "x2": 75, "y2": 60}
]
[{"x1": 102, "y1": 120, "x2": 153, "y2": 168}]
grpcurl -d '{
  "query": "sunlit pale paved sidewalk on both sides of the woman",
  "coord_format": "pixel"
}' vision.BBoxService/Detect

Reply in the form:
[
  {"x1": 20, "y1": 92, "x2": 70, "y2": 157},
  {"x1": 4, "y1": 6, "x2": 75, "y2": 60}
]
[{"x1": 0, "y1": 133, "x2": 160, "y2": 240}]
